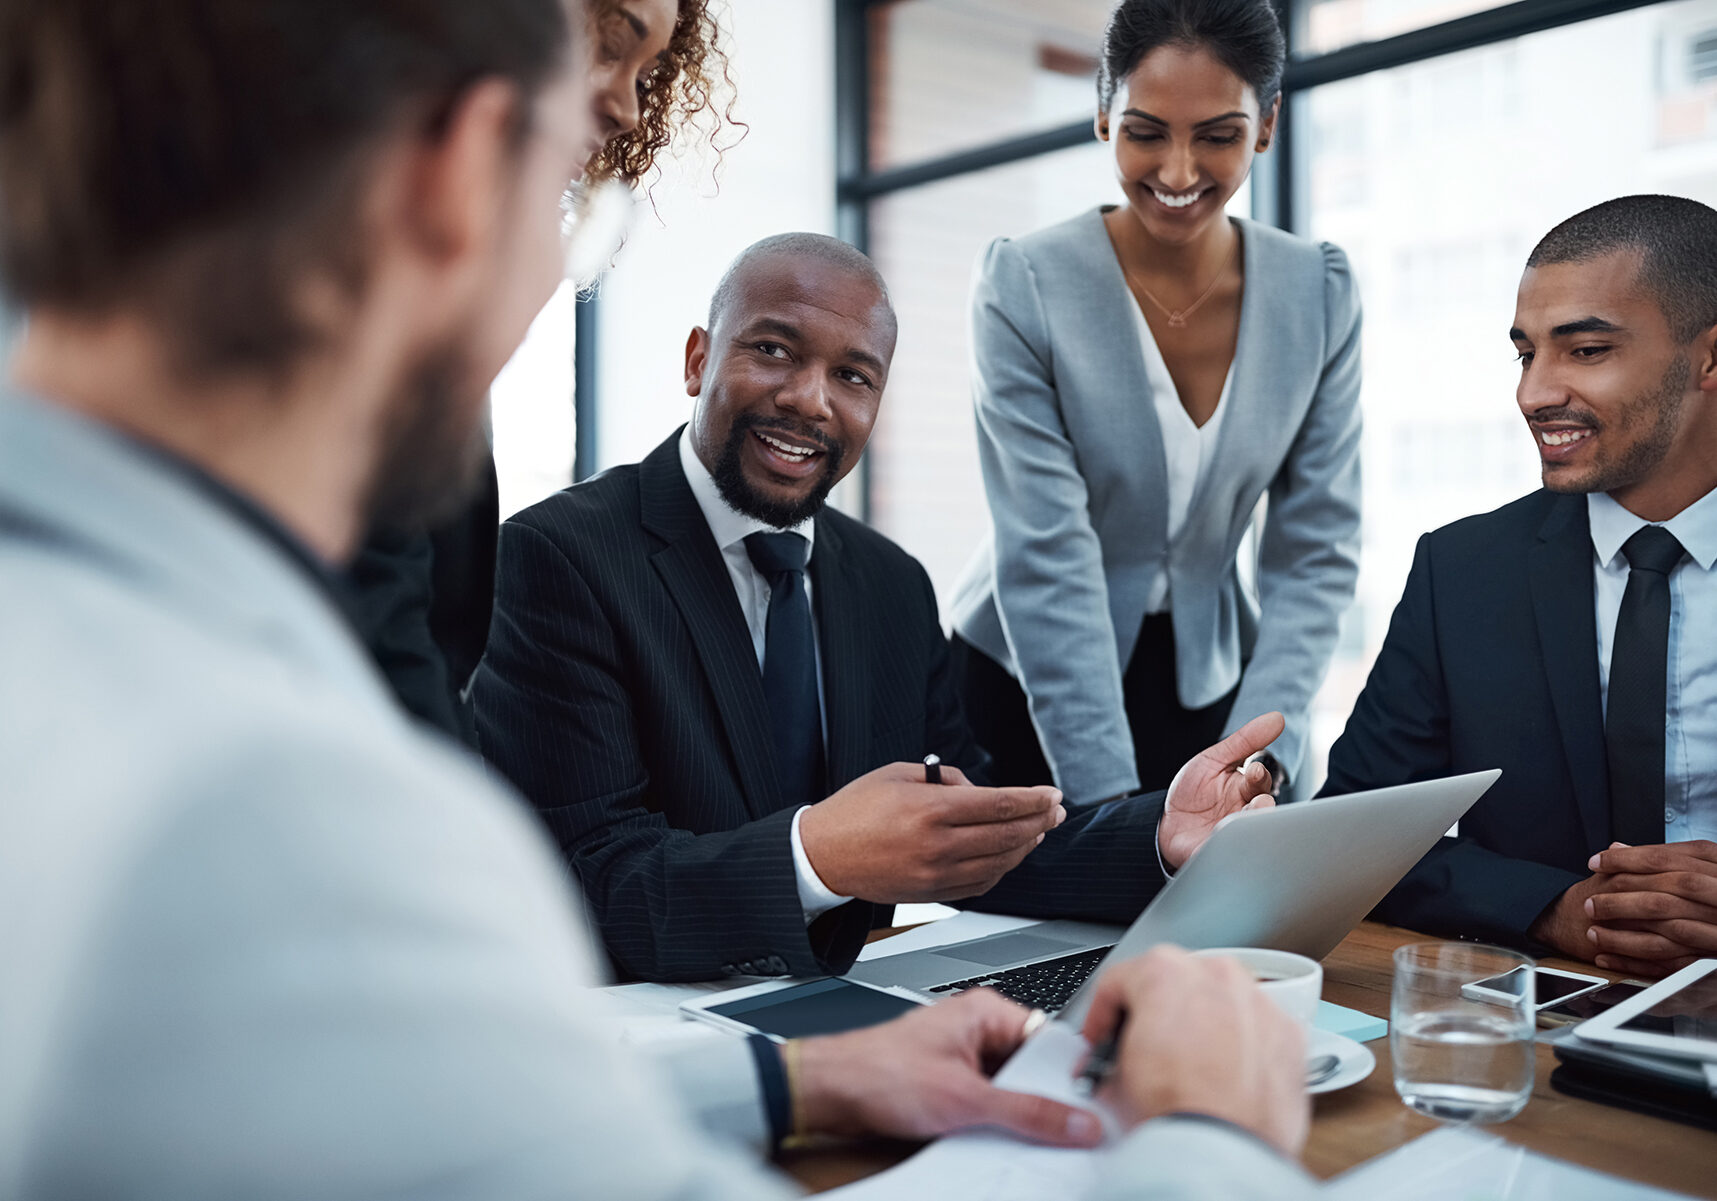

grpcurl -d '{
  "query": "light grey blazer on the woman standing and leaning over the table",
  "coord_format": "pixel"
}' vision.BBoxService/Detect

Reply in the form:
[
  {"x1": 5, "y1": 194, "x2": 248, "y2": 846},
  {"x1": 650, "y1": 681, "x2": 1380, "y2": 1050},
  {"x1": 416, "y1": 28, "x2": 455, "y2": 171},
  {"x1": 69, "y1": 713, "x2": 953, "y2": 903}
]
[{"x1": 953, "y1": 210, "x2": 1360, "y2": 802}]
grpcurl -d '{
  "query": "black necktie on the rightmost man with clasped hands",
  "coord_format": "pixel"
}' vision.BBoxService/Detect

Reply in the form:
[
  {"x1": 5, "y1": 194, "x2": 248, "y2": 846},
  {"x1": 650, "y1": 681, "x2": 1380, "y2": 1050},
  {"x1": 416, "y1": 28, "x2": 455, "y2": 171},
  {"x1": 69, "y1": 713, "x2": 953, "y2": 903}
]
[{"x1": 1604, "y1": 526, "x2": 1683, "y2": 847}]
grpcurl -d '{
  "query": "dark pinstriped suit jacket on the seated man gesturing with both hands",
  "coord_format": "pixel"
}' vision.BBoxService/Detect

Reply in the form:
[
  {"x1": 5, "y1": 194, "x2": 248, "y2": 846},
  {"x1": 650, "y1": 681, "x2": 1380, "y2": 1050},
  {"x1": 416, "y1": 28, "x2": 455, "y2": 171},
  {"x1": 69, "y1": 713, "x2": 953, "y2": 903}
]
[{"x1": 477, "y1": 435, "x2": 1162, "y2": 979}]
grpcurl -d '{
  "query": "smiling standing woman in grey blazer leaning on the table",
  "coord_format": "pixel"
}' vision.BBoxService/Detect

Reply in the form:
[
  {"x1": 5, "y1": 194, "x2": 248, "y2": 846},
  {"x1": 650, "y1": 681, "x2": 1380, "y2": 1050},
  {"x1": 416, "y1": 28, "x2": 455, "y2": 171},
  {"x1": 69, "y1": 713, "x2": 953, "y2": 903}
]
[{"x1": 953, "y1": 0, "x2": 1360, "y2": 804}]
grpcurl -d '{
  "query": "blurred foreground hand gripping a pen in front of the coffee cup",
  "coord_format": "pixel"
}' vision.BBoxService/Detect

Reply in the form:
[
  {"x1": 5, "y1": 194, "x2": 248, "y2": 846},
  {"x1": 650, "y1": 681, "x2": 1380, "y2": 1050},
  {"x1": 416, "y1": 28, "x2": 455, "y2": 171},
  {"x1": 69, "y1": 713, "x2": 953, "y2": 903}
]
[{"x1": 1080, "y1": 947, "x2": 1312, "y2": 1156}]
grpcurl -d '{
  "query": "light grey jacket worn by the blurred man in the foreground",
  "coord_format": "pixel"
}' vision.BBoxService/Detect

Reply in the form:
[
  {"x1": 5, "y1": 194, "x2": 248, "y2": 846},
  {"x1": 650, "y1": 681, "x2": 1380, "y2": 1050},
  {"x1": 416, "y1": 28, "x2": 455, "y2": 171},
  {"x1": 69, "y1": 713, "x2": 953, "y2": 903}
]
[{"x1": 0, "y1": 393, "x2": 1301, "y2": 1201}]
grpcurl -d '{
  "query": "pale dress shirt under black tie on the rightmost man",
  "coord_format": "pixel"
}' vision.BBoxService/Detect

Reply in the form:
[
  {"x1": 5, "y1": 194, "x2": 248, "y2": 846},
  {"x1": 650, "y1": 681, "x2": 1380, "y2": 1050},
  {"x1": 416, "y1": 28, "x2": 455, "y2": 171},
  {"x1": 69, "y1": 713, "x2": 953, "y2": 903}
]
[{"x1": 1587, "y1": 490, "x2": 1717, "y2": 842}]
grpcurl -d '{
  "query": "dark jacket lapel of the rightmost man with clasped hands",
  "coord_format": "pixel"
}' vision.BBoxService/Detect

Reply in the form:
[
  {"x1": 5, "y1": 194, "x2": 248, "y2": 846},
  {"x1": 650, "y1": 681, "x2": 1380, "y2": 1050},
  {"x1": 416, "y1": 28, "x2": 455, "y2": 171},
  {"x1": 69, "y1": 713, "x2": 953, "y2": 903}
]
[{"x1": 1528, "y1": 497, "x2": 1611, "y2": 849}]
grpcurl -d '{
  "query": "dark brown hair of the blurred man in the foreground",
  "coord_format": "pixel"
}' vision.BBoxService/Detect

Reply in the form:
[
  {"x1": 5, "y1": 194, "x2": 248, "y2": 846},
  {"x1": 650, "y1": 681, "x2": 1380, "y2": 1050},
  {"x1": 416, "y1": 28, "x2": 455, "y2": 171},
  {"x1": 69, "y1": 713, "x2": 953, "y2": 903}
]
[{"x1": 0, "y1": 0, "x2": 568, "y2": 371}]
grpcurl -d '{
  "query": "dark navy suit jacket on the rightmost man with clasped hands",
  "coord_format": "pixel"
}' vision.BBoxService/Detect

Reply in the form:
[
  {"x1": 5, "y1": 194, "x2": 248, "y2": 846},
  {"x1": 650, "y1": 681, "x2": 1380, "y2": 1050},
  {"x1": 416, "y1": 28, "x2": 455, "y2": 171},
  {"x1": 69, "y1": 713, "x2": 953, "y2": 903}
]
[{"x1": 1324, "y1": 491, "x2": 1611, "y2": 945}]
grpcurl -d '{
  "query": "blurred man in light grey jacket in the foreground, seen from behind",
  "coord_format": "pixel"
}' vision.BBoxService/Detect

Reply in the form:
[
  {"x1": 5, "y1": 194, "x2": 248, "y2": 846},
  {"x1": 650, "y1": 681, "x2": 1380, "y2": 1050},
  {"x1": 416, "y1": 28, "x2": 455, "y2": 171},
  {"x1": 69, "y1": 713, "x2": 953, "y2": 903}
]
[{"x1": 0, "y1": 0, "x2": 1305, "y2": 1201}]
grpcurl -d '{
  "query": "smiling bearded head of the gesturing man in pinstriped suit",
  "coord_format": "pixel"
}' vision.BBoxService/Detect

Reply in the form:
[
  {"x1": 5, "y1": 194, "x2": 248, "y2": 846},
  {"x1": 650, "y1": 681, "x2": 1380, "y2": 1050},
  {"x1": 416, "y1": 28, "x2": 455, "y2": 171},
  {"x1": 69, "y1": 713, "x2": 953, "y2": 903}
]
[{"x1": 685, "y1": 251, "x2": 895, "y2": 529}]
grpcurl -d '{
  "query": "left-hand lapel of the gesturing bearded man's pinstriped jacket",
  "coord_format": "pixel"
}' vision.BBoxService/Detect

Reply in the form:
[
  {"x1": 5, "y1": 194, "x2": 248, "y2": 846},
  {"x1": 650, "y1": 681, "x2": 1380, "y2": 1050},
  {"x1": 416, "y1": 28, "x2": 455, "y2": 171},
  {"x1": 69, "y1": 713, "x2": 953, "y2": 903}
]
[{"x1": 639, "y1": 431, "x2": 785, "y2": 818}]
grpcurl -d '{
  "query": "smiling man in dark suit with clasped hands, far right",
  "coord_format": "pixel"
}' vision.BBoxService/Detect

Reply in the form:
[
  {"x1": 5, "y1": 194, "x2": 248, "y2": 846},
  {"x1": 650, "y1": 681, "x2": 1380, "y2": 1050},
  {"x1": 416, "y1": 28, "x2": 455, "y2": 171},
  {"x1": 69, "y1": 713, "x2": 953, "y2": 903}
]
[{"x1": 1326, "y1": 196, "x2": 1717, "y2": 976}]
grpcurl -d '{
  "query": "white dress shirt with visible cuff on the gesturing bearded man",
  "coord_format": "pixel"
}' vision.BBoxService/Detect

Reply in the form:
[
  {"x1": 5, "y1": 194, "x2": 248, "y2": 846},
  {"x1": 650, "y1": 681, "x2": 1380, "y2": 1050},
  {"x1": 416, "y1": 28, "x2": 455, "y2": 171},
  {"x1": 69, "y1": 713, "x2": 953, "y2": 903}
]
[{"x1": 680, "y1": 426, "x2": 852, "y2": 926}]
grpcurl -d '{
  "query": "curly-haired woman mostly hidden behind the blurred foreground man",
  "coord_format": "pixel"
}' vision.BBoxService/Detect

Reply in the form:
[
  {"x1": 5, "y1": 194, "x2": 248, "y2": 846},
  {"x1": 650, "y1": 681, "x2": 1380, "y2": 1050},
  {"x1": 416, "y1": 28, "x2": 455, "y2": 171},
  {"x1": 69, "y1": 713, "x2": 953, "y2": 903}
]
[{"x1": 349, "y1": 0, "x2": 737, "y2": 746}]
